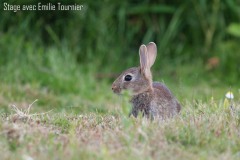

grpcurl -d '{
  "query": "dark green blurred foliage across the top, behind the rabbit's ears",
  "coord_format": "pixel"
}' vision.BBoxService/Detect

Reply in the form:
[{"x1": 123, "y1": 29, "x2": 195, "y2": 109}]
[{"x1": 0, "y1": 0, "x2": 240, "y2": 84}]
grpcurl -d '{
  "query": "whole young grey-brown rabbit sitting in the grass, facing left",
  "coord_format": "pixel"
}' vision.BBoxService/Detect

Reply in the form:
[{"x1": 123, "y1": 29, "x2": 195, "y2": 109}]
[{"x1": 112, "y1": 42, "x2": 181, "y2": 119}]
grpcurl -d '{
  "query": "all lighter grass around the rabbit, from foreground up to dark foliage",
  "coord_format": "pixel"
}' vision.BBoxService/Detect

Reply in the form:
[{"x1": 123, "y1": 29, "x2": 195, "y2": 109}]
[{"x1": 0, "y1": 33, "x2": 240, "y2": 160}]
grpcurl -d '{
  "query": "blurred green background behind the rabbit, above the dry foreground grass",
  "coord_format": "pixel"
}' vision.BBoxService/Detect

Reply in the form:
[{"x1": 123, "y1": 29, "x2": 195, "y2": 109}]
[{"x1": 0, "y1": 0, "x2": 240, "y2": 113}]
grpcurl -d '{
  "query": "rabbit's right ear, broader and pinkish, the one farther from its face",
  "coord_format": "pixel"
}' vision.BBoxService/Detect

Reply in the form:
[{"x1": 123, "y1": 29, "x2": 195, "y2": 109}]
[{"x1": 147, "y1": 42, "x2": 157, "y2": 68}]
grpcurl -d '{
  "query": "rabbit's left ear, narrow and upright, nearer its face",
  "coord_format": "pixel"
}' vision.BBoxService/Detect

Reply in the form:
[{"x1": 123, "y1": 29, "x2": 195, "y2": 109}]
[{"x1": 139, "y1": 44, "x2": 150, "y2": 77}]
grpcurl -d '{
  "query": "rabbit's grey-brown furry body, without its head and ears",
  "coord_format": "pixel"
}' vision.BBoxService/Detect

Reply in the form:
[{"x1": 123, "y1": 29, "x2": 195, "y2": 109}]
[{"x1": 131, "y1": 82, "x2": 181, "y2": 119}]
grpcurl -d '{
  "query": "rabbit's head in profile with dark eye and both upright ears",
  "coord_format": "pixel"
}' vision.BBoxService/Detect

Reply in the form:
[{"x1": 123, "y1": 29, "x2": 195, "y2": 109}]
[{"x1": 112, "y1": 42, "x2": 157, "y2": 95}]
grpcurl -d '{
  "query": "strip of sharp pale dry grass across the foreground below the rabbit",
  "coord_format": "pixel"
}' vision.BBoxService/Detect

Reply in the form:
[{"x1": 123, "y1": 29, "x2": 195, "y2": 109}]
[{"x1": 0, "y1": 99, "x2": 240, "y2": 160}]
